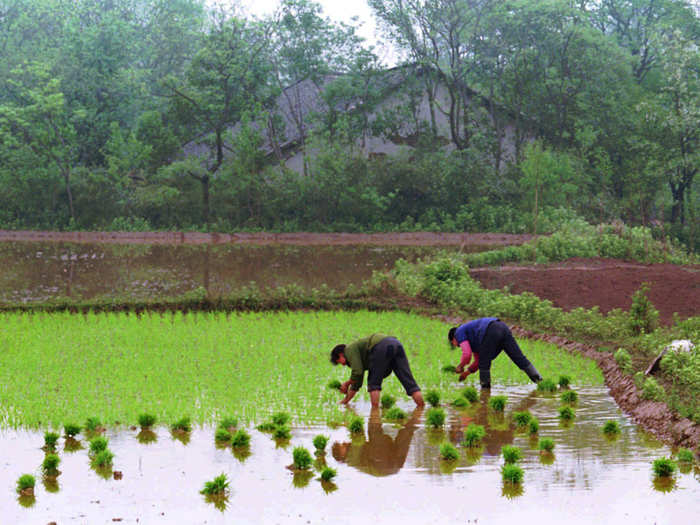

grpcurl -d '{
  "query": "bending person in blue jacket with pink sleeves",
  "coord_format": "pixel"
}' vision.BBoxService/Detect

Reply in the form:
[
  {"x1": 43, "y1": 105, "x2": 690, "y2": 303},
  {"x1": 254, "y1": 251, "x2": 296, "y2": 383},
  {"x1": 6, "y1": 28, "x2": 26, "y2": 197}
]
[{"x1": 447, "y1": 317, "x2": 542, "y2": 388}]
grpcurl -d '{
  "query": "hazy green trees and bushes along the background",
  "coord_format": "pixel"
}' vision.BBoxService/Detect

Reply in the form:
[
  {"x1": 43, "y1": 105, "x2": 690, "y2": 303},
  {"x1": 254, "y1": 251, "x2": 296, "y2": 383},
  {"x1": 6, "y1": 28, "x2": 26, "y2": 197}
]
[{"x1": 0, "y1": 0, "x2": 700, "y2": 249}]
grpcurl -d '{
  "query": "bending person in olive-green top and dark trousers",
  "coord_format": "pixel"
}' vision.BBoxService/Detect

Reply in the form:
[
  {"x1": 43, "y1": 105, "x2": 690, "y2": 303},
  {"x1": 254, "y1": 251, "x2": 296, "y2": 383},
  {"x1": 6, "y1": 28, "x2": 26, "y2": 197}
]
[{"x1": 331, "y1": 334, "x2": 424, "y2": 407}]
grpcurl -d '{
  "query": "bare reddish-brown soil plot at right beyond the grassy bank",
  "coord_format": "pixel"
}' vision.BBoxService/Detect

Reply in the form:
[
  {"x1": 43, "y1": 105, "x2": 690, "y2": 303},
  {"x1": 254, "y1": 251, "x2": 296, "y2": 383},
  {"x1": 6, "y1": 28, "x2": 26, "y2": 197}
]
[{"x1": 470, "y1": 259, "x2": 700, "y2": 325}]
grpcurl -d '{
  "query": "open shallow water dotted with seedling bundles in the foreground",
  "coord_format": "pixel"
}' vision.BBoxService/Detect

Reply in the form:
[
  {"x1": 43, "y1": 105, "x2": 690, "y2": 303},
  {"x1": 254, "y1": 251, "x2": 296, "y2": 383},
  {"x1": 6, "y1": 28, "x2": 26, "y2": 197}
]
[{"x1": 0, "y1": 387, "x2": 700, "y2": 525}]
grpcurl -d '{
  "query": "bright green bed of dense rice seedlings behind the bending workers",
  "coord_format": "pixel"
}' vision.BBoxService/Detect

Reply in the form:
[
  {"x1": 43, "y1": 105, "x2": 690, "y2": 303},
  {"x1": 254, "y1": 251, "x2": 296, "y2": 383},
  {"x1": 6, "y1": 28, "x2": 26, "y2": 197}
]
[{"x1": 0, "y1": 311, "x2": 603, "y2": 429}]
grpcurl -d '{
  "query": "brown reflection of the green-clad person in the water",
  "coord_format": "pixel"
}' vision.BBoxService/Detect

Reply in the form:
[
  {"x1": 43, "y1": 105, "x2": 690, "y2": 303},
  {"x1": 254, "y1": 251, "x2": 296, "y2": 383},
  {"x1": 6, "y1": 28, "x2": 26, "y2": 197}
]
[{"x1": 331, "y1": 407, "x2": 423, "y2": 476}]
